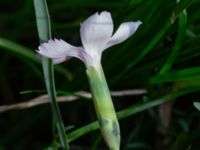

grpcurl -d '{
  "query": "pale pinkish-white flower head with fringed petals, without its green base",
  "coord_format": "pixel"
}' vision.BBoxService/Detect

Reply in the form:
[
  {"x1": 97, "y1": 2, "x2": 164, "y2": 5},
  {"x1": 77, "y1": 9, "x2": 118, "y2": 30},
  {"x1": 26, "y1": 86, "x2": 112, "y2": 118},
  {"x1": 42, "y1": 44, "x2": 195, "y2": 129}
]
[{"x1": 37, "y1": 11, "x2": 141, "y2": 67}]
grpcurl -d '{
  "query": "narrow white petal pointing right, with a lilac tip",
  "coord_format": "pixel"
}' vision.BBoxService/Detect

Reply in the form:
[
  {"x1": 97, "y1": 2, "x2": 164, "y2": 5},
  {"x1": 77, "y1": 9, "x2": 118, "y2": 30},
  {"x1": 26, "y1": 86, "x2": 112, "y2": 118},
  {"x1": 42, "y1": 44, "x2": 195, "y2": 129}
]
[{"x1": 107, "y1": 21, "x2": 142, "y2": 48}]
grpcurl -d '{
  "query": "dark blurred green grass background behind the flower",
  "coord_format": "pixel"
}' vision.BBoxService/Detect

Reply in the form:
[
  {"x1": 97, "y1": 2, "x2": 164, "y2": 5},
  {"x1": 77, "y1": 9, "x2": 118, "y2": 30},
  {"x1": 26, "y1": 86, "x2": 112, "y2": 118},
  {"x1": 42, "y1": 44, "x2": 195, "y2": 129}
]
[{"x1": 0, "y1": 0, "x2": 200, "y2": 150}]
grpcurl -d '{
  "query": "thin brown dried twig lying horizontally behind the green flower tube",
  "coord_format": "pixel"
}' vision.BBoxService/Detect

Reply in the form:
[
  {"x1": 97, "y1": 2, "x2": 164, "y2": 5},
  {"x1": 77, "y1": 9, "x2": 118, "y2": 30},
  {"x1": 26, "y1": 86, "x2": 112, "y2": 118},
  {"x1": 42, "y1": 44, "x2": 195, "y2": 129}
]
[{"x1": 0, "y1": 89, "x2": 147, "y2": 113}]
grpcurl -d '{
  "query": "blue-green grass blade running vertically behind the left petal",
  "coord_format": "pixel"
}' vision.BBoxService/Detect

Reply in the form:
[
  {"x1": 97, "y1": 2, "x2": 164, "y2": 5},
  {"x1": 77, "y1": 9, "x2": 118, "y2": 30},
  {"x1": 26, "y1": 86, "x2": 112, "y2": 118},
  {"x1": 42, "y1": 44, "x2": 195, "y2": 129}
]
[{"x1": 34, "y1": 0, "x2": 69, "y2": 150}]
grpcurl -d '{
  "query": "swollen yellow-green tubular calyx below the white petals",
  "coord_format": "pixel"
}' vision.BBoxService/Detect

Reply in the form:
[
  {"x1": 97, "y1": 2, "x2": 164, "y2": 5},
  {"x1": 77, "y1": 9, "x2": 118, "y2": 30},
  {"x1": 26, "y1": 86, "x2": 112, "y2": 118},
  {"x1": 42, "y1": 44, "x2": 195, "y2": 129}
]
[{"x1": 86, "y1": 65, "x2": 120, "y2": 150}]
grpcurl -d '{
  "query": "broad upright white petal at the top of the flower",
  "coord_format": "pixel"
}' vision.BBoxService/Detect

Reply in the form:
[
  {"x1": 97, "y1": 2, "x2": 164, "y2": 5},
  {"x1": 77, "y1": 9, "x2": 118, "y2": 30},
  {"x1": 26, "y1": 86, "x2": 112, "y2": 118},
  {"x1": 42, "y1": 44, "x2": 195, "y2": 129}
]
[{"x1": 80, "y1": 11, "x2": 113, "y2": 56}]
